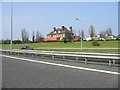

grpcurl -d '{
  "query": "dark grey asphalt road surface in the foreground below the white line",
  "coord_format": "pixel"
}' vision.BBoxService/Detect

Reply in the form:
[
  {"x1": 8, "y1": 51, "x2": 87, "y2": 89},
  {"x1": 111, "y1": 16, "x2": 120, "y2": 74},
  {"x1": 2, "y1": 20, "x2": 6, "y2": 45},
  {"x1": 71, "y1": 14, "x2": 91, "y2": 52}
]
[{"x1": 2, "y1": 57, "x2": 118, "y2": 88}]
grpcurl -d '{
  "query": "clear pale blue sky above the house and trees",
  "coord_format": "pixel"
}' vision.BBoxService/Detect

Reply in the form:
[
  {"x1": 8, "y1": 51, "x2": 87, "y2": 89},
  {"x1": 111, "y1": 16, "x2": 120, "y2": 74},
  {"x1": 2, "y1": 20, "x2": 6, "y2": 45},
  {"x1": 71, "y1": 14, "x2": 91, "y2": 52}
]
[{"x1": 2, "y1": 2, "x2": 118, "y2": 39}]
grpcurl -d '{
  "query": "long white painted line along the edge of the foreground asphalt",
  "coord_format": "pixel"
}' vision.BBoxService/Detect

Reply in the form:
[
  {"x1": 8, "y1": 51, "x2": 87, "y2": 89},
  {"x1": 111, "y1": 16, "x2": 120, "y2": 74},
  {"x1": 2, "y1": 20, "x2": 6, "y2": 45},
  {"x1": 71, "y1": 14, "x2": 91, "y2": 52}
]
[{"x1": 0, "y1": 55, "x2": 120, "y2": 75}]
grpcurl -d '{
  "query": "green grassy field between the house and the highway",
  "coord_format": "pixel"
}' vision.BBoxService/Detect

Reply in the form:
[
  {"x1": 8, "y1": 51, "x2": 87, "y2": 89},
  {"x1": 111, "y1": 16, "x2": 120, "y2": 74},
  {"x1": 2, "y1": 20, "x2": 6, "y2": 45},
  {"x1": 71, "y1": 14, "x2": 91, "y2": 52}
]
[{"x1": 0, "y1": 41, "x2": 120, "y2": 52}]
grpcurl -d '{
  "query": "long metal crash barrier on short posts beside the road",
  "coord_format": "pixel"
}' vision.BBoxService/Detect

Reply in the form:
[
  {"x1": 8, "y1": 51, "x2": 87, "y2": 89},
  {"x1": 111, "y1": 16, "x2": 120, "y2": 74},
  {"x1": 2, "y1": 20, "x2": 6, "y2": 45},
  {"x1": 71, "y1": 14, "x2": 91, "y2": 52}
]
[{"x1": 0, "y1": 50, "x2": 120, "y2": 67}]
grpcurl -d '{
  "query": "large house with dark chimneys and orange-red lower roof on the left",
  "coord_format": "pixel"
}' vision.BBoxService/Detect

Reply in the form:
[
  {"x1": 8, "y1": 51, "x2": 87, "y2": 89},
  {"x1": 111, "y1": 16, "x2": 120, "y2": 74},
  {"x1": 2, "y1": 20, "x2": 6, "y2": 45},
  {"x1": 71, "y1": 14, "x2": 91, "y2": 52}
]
[{"x1": 43, "y1": 26, "x2": 74, "y2": 42}]
